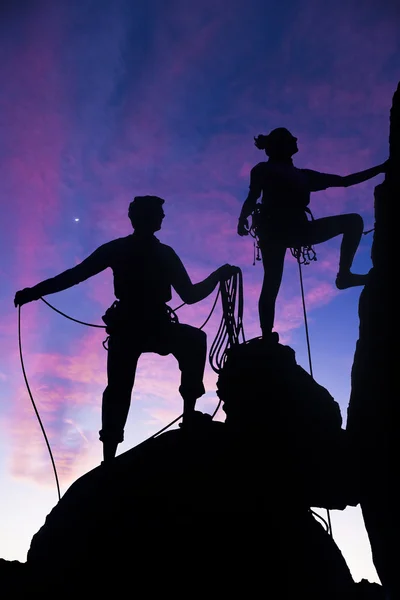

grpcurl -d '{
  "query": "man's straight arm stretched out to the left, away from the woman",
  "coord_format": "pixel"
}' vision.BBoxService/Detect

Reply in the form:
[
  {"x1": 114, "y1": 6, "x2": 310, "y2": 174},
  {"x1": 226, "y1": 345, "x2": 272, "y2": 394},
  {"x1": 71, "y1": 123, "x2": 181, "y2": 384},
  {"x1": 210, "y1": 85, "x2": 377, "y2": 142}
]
[{"x1": 14, "y1": 244, "x2": 110, "y2": 306}]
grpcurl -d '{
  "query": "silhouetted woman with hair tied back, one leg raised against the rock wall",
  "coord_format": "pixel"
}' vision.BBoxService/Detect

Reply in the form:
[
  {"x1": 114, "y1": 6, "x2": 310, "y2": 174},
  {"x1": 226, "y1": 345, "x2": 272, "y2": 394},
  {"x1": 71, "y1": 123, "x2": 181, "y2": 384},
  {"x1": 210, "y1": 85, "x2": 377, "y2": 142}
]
[{"x1": 237, "y1": 127, "x2": 386, "y2": 339}]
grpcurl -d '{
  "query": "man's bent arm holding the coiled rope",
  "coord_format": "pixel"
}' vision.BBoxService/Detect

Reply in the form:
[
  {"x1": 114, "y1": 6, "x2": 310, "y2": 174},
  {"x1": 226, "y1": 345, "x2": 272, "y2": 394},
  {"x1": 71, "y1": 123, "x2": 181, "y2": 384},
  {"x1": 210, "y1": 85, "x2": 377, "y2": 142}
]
[{"x1": 171, "y1": 251, "x2": 238, "y2": 304}]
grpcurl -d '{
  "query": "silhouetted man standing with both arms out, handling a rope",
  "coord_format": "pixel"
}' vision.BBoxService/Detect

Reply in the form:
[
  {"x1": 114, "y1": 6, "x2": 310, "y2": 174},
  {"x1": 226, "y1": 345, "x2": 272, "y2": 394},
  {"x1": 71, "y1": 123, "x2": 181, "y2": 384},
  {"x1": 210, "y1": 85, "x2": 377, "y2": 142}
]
[{"x1": 14, "y1": 196, "x2": 236, "y2": 460}]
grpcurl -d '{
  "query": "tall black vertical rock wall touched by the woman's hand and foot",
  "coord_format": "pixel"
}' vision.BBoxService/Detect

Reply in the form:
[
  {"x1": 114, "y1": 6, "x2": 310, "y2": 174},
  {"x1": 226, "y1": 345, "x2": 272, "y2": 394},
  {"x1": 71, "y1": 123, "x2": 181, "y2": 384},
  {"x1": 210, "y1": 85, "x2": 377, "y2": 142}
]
[{"x1": 347, "y1": 85, "x2": 400, "y2": 598}]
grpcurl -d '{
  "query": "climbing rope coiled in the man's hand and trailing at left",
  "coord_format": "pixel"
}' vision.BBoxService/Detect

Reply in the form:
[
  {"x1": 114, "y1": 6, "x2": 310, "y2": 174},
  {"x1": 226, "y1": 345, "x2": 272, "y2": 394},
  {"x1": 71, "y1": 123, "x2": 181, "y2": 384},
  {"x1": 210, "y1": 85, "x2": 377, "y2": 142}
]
[{"x1": 18, "y1": 269, "x2": 245, "y2": 500}]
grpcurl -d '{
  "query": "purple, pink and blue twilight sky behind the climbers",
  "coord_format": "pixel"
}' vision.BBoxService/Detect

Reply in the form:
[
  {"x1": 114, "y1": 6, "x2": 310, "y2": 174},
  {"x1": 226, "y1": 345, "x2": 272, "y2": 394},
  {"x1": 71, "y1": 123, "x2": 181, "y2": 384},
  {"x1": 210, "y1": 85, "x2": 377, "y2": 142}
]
[{"x1": 0, "y1": 0, "x2": 400, "y2": 581}]
